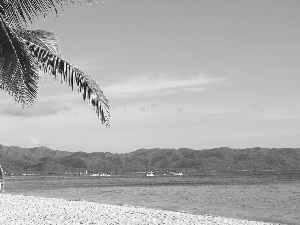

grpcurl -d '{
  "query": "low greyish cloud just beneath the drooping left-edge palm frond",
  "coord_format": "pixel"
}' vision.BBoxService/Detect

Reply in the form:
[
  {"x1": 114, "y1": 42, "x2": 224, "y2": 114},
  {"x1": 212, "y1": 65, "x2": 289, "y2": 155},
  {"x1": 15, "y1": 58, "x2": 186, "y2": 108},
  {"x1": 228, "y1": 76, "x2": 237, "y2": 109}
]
[{"x1": 0, "y1": 100, "x2": 70, "y2": 117}]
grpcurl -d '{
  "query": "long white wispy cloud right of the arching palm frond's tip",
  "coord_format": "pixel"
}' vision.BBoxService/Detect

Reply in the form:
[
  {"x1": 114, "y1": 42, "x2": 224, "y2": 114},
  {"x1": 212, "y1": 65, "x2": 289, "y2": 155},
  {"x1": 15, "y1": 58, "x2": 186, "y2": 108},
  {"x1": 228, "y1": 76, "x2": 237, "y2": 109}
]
[{"x1": 105, "y1": 74, "x2": 223, "y2": 98}]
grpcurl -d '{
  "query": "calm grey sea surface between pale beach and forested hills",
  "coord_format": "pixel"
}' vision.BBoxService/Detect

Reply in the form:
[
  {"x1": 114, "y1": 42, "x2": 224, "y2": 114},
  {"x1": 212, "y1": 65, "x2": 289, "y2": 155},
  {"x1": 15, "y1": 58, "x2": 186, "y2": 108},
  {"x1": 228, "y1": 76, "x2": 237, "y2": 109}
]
[{"x1": 5, "y1": 171, "x2": 300, "y2": 225}]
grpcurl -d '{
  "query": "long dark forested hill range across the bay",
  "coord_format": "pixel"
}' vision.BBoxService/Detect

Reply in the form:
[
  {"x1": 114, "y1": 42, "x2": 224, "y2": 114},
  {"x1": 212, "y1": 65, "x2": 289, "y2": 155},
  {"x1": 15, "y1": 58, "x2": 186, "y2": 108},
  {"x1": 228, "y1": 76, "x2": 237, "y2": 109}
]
[{"x1": 0, "y1": 145, "x2": 300, "y2": 174}]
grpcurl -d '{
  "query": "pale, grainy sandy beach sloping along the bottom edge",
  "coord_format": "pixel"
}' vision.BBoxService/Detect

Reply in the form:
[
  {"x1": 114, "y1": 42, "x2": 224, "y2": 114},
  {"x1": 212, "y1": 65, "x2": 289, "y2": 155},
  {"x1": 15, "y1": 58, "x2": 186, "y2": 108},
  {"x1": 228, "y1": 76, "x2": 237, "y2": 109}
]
[{"x1": 0, "y1": 194, "x2": 282, "y2": 225}]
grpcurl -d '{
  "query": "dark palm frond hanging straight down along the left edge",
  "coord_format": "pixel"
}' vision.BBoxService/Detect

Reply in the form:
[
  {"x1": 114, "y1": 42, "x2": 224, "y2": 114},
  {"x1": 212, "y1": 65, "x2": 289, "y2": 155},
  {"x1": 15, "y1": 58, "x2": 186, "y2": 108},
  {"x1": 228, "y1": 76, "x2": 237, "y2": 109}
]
[{"x1": 0, "y1": 17, "x2": 39, "y2": 106}]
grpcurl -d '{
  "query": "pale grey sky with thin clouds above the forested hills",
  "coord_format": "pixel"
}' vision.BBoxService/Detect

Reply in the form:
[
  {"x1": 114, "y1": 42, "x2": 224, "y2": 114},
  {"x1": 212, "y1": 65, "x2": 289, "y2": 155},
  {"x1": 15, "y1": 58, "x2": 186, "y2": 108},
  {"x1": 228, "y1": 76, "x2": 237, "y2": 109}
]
[{"x1": 0, "y1": 0, "x2": 300, "y2": 153}]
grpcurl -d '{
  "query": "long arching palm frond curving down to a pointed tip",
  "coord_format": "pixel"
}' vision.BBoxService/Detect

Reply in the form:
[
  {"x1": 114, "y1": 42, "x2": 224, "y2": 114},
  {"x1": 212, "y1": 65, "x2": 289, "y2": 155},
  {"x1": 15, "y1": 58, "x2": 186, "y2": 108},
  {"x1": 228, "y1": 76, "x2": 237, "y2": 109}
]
[{"x1": 23, "y1": 39, "x2": 110, "y2": 127}]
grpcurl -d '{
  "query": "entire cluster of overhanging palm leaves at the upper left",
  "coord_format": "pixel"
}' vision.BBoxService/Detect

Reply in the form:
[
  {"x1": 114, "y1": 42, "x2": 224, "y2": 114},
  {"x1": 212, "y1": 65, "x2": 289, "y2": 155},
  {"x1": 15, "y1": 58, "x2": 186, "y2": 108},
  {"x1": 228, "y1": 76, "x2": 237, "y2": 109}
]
[{"x1": 0, "y1": 0, "x2": 110, "y2": 126}]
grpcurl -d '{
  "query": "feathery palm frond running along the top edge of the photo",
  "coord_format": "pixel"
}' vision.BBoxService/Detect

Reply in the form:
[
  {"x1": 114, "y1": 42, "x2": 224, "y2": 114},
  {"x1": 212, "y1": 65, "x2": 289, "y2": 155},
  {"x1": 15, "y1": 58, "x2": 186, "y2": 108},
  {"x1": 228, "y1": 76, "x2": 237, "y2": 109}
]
[{"x1": 0, "y1": 0, "x2": 97, "y2": 27}]
